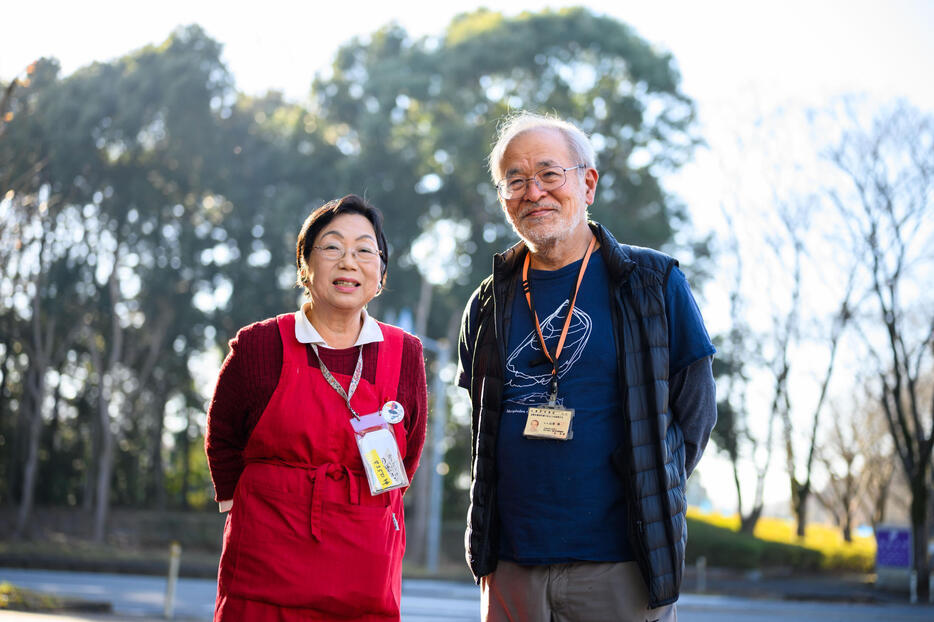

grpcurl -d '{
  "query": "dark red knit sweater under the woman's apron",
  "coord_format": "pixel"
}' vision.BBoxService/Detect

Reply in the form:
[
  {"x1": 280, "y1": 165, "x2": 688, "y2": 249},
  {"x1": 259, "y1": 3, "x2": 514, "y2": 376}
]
[{"x1": 204, "y1": 318, "x2": 428, "y2": 501}]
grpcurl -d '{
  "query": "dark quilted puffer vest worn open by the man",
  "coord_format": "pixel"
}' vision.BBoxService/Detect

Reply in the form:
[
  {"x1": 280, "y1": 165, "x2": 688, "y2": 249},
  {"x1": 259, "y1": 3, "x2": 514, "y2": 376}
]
[{"x1": 465, "y1": 223, "x2": 687, "y2": 607}]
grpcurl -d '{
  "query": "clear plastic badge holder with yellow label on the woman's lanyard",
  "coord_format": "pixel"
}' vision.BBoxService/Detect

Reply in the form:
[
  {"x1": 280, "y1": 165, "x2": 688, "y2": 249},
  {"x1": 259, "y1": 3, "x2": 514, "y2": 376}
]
[{"x1": 350, "y1": 412, "x2": 409, "y2": 496}]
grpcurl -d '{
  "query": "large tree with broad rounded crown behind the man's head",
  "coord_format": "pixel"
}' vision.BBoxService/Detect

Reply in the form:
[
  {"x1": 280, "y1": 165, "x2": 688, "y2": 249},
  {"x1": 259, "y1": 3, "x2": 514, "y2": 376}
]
[{"x1": 312, "y1": 4, "x2": 697, "y2": 337}]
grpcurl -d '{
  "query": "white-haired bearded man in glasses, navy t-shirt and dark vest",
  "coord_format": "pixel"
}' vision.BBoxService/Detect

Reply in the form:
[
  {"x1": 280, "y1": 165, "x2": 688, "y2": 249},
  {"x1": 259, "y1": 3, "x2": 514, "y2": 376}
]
[{"x1": 458, "y1": 113, "x2": 717, "y2": 622}]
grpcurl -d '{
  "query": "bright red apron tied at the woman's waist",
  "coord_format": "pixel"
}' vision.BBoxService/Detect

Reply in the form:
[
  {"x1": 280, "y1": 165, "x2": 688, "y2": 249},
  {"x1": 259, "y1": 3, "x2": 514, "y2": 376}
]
[{"x1": 214, "y1": 314, "x2": 405, "y2": 622}]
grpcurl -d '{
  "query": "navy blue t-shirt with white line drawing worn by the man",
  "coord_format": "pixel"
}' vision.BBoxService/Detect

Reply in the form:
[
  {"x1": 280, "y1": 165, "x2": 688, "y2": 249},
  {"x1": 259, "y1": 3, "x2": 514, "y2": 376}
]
[{"x1": 497, "y1": 253, "x2": 714, "y2": 564}]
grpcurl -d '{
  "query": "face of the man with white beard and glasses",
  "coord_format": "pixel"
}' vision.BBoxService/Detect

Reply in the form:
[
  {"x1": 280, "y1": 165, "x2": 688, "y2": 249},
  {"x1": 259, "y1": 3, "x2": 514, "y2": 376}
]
[{"x1": 500, "y1": 128, "x2": 597, "y2": 251}]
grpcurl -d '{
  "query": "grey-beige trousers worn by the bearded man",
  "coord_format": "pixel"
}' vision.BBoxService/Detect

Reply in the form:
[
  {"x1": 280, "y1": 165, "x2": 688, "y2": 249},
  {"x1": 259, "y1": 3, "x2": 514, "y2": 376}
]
[{"x1": 480, "y1": 561, "x2": 678, "y2": 622}]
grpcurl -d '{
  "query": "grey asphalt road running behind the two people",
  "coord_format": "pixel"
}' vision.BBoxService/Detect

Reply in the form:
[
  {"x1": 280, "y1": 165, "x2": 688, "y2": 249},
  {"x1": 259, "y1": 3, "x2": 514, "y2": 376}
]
[{"x1": 0, "y1": 568, "x2": 934, "y2": 622}]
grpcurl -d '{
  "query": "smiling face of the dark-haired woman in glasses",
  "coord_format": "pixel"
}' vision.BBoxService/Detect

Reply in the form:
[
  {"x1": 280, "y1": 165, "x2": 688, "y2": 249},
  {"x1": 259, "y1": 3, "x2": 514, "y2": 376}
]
[{"x1": 308, "y1": 214, "x2": 382, "y2": 314}]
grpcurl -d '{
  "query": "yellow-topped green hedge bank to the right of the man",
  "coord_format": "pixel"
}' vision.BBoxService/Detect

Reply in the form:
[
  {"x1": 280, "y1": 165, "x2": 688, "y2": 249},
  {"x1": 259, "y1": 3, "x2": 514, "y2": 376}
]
[{"x1": 687, "y1": 508, "x2": 876, "y2": 572}]
